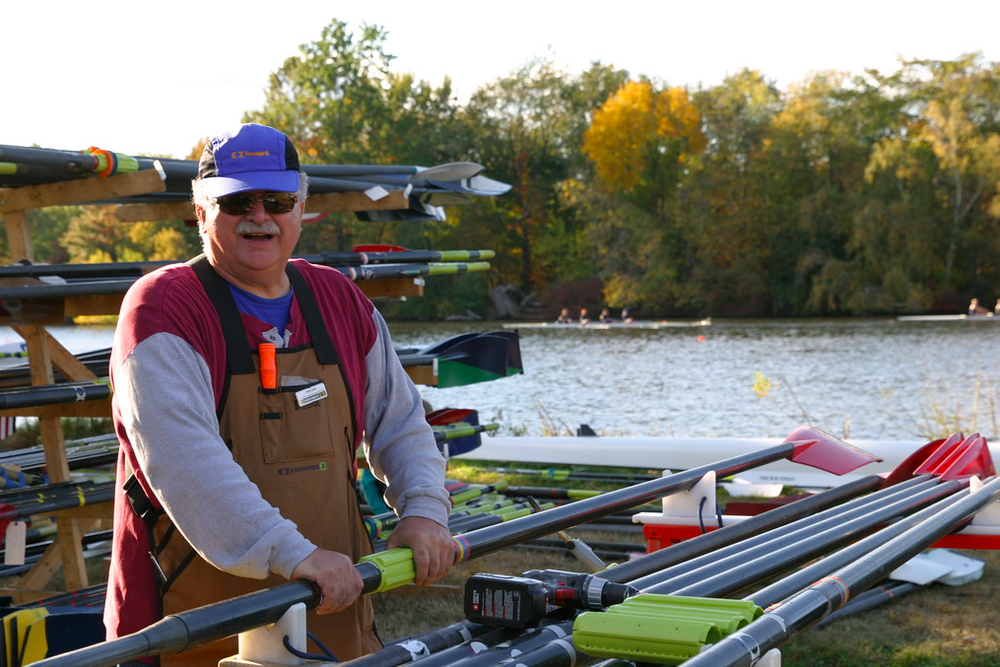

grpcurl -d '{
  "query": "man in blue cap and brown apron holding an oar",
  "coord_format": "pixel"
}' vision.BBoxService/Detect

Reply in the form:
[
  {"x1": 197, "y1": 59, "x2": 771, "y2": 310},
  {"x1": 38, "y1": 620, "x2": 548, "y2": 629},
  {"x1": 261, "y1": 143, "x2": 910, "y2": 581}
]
[{"x1": 105, "y1": 124, "x2": 454, "y2": 665}]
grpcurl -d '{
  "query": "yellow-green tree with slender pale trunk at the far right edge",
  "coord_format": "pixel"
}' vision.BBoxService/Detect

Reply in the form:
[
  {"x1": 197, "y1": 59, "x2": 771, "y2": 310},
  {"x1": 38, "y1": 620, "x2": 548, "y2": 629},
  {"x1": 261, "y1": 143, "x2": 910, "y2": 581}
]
[{"x1": 866, "y1": 54, "x2": 1000, "y2": 308}]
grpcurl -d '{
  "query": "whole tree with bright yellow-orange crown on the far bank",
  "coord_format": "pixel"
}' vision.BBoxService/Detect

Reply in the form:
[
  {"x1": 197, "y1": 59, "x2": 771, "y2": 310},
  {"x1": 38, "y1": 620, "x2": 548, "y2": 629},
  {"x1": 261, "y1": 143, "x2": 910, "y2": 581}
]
[{"x1": 583, "y1": 81, "x2": 706, "y2": 310}]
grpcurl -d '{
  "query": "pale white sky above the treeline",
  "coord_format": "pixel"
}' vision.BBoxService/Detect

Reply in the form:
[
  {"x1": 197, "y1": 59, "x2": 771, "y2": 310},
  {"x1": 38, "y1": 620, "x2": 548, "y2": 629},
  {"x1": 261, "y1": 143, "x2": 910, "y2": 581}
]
[{"x1": 0, "y1": 0, "x2": 1000, "y2": 157}]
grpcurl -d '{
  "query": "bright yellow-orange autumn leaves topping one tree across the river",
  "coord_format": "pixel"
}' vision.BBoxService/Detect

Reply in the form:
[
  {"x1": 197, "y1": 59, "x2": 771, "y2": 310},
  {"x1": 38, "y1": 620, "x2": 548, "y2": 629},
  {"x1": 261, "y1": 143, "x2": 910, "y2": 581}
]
[{"x1": 583, "y1": 81, "x2": 706, "y2": 192}]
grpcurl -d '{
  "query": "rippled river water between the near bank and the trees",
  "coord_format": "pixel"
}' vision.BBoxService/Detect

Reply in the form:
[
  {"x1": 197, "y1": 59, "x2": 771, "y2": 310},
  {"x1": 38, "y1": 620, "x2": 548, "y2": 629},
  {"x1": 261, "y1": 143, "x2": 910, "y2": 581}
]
[{"x1": 15, "y1": 318, "x2": 1000, "y2": 440}]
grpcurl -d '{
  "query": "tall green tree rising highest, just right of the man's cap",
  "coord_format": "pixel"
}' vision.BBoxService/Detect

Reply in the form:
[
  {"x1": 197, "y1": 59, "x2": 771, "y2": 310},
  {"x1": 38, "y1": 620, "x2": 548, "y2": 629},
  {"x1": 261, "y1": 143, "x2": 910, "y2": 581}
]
[{"x1": 245, "y1": 20, "x2": 465, "y2": 252}]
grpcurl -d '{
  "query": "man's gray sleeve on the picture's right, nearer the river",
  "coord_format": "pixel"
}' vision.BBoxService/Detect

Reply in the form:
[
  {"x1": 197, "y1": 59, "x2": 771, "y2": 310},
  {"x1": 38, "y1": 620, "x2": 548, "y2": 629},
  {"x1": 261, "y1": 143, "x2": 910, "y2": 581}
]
[{"x1": 365, "y1": 310, "x2": 451, "y2": 526}]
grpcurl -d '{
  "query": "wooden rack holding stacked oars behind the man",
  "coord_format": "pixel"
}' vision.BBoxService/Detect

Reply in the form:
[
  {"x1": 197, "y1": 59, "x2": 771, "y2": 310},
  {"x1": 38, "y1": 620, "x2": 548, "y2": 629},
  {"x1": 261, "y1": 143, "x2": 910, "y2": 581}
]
[{"x1": 0, "y1": 164, "x2": 424, "y2": 602}]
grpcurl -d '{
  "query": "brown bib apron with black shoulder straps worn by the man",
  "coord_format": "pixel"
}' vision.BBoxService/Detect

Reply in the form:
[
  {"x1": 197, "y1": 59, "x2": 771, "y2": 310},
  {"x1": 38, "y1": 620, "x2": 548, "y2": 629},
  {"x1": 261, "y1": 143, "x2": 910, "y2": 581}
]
[{"x1": 147, "y1": 262, "x2": 381, "y2": 667}]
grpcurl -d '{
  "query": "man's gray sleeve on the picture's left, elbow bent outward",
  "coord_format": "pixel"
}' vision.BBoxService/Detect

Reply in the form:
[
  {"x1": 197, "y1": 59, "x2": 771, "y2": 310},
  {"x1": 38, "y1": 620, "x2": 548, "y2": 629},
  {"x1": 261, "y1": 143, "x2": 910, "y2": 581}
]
[{"x1": 115, "y1": 333, "x2": 316, "y2": 579}]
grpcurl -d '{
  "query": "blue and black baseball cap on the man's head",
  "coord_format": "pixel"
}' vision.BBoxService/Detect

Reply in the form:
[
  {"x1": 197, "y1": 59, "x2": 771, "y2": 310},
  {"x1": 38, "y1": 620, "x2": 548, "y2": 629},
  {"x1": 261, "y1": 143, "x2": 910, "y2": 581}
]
[{"x1": 198, "y1": 123, "x2": 299, "y2": 198}]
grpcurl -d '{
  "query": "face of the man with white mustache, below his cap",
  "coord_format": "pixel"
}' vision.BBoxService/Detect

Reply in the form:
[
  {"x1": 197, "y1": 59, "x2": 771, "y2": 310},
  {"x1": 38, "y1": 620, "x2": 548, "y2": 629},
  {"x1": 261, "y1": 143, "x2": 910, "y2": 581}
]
[{"x1": 198, "y1": 191, "x2": 305, "y2": 285}]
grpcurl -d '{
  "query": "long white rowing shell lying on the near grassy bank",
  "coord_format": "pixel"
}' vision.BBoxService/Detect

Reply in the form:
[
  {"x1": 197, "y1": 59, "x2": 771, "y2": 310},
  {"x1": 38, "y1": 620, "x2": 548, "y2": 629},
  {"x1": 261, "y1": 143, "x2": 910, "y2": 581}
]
[{"x1": 458, "y1": 436, "x2": 948, "y2": 488}]
